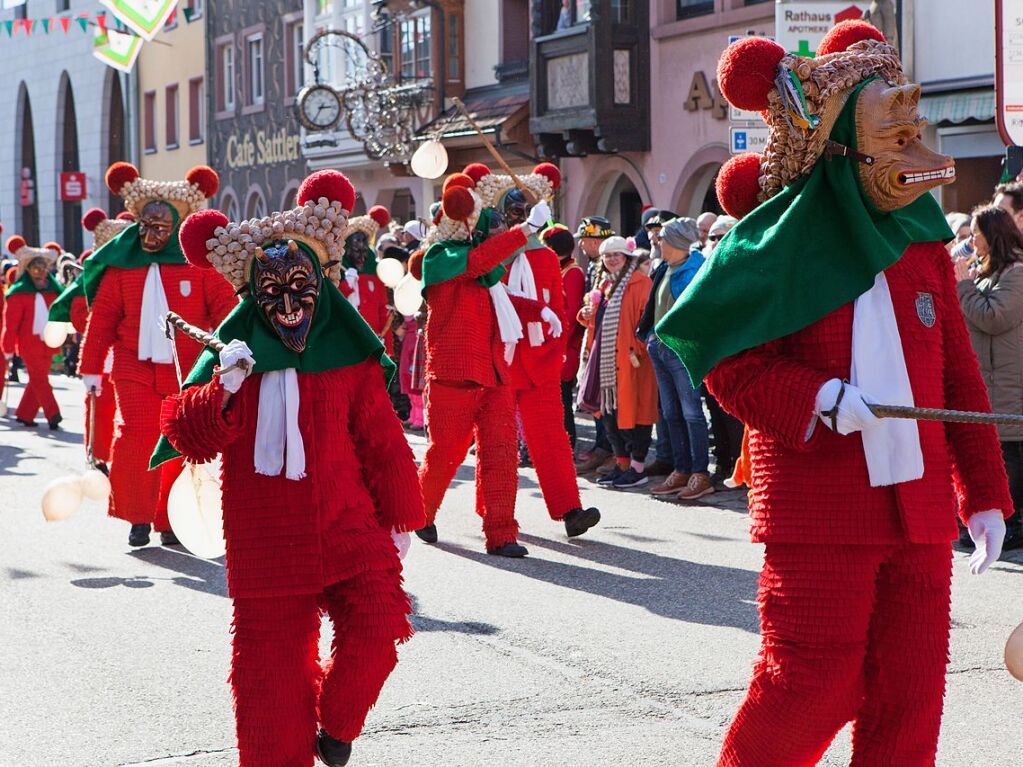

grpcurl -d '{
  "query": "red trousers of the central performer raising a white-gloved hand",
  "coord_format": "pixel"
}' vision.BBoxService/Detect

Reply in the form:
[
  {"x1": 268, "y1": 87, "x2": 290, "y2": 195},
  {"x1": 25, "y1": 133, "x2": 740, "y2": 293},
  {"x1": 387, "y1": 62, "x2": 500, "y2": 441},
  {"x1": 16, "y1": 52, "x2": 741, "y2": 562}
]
[{"x1": 419, "y1": 380, "x2": 519, "y2": 548}]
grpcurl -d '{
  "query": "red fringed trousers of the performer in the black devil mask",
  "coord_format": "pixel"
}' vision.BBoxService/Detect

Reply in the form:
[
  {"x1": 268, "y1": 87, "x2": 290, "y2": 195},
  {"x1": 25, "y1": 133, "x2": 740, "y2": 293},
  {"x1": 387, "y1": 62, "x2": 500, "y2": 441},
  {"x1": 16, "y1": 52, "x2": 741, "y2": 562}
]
[{"x1": 231, "y1": 570, "x2": 412, "y2": 767}]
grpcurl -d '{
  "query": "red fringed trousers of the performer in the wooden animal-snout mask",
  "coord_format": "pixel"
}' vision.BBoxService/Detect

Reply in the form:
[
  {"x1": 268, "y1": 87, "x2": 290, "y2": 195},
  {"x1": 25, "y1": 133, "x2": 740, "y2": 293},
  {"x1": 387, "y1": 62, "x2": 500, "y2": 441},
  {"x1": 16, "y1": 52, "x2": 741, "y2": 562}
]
[{"x1": 718, "y1": 543, "x2": 951, "y2": 767}]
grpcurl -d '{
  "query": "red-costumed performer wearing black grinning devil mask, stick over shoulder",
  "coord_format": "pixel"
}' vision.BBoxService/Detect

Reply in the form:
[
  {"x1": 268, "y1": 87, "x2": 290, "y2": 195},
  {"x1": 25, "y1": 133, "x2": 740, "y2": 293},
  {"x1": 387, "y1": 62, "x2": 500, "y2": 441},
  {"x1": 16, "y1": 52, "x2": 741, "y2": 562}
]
[{"x1": 154, "y1": 171, "x2": 424, "y2": 767}]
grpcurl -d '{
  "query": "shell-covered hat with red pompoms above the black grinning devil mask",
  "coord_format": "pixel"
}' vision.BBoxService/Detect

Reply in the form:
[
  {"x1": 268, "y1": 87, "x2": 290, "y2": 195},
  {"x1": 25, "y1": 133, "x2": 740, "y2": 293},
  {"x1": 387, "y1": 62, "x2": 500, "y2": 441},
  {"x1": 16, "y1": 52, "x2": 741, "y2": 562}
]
[{"x1": 178, "y1": 171, "x2": 355, "y2": 290}]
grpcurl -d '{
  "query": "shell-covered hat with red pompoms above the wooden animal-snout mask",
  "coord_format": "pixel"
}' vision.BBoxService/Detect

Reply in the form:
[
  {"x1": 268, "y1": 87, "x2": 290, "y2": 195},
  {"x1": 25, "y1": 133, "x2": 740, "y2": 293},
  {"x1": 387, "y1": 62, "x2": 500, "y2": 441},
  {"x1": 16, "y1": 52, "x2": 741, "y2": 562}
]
[{"x1": 717, "y1": 20, "x2": 906, "y2": 218}]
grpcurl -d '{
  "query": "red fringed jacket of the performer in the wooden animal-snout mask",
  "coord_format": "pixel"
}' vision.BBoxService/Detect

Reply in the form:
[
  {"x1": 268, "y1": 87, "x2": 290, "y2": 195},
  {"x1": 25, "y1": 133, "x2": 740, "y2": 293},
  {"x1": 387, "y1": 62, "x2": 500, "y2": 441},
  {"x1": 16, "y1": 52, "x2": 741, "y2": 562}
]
[{"x1": 707, "y1": 242, "x2": 1013, "y2": 544}]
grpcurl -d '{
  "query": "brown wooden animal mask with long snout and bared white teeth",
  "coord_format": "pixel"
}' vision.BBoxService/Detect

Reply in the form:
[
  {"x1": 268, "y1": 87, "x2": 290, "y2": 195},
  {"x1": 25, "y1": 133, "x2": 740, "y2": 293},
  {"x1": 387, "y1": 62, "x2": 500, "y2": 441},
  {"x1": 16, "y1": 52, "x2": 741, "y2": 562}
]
[{"x1": 856, "y1": 80, "x2": 955, "y2": 213}]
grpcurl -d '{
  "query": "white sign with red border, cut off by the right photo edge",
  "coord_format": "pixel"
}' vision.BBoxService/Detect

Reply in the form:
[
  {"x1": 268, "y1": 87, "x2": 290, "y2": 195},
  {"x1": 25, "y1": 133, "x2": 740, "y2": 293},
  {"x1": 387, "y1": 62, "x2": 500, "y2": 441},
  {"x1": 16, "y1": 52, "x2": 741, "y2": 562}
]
[{"x1": 994, "y1": 0, "x2": 1023, "y2": 145}]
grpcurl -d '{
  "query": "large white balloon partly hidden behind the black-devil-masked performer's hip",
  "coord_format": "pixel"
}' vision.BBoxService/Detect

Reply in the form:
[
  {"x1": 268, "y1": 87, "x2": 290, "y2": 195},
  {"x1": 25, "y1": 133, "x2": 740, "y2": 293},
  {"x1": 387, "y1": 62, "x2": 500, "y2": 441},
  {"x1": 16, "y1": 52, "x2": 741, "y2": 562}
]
[{"x1": 167, "y1": 458, "x2": 227, "y2": 559}]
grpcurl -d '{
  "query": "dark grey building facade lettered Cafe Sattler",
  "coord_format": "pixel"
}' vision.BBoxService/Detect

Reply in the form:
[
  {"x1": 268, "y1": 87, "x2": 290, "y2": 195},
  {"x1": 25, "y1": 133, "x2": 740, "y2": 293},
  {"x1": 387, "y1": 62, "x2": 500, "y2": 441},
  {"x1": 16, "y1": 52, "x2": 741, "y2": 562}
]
[{"x1": 205, "y1": 0, "x2": 307, "y2": 221}]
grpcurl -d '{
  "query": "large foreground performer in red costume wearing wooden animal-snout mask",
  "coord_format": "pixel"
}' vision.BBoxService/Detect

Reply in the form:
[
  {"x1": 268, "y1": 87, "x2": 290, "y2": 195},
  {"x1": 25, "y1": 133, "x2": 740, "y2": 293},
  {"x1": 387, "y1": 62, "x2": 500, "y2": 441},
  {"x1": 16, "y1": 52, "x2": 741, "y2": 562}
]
[{"x1": 658, "y1": 22, "x2": 1012, "y2": 767}]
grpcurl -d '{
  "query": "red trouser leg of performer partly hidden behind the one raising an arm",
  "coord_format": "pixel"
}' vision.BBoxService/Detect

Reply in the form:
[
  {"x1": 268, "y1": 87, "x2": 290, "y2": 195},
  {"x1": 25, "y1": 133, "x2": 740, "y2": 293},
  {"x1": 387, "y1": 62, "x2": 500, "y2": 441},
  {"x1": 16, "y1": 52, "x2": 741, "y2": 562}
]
[{"x1": 516, "y1": 381, "x2": 582, "y2": 520}]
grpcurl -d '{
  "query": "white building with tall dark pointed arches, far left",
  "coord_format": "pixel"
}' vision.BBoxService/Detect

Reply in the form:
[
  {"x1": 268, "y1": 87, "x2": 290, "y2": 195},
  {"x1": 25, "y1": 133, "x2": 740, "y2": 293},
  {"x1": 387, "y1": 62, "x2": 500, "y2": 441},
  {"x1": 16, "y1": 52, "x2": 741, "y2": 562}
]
[{"x1": 0, "y1": 0, "x2": 132, "y2": 253}]
